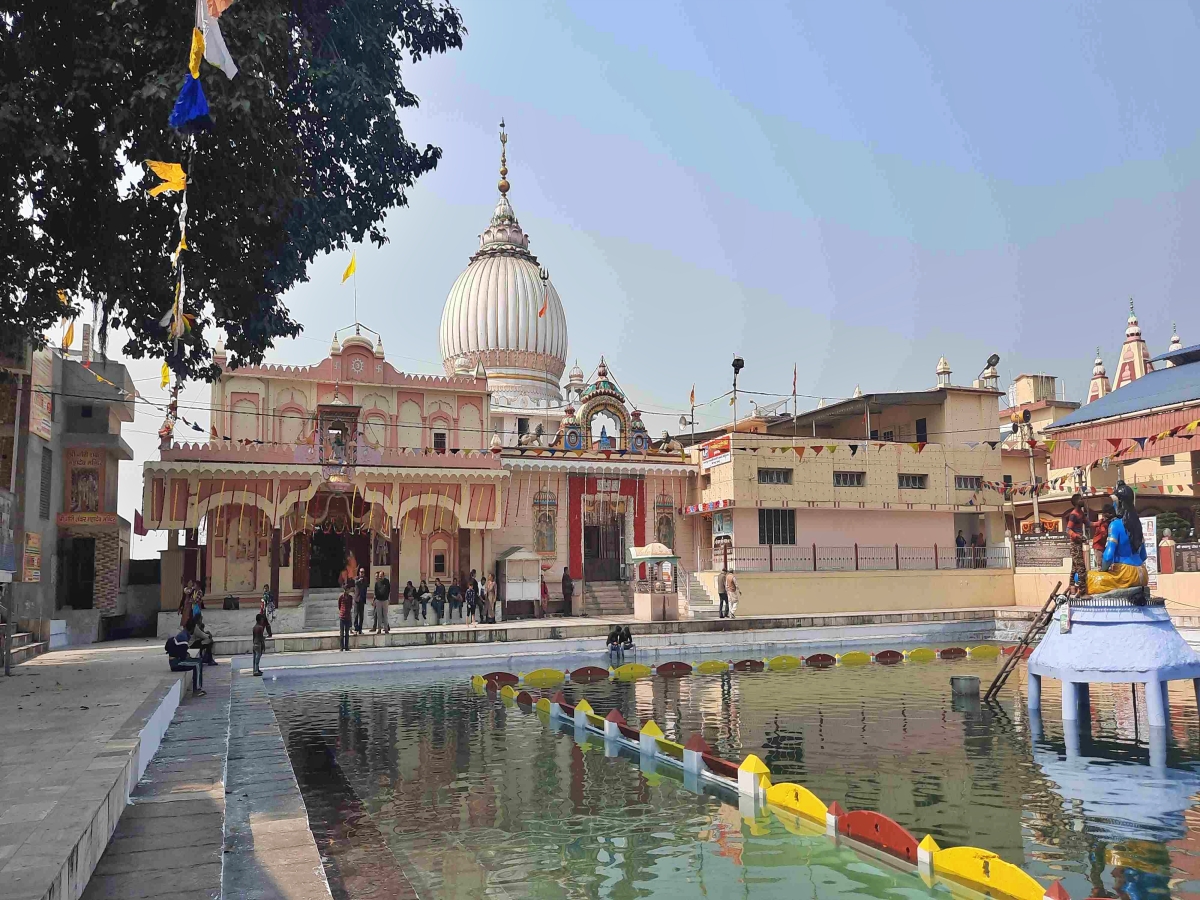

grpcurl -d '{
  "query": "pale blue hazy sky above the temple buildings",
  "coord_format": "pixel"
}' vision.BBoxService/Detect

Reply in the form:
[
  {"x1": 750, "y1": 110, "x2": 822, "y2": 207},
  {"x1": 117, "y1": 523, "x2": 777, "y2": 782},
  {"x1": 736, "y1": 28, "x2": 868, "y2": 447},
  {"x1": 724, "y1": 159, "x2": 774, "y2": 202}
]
[{"x1": 118, "y1": 0, "x2": 1200, "y2": 557}]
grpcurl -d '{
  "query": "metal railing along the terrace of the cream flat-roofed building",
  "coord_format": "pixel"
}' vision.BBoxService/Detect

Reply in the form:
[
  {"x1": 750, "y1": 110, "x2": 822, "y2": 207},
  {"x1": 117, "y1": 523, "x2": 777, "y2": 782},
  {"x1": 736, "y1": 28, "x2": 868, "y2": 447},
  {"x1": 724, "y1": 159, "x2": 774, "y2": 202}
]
[{"x1": 712, "y1": 544, "x2": 1013, "y2": 572}]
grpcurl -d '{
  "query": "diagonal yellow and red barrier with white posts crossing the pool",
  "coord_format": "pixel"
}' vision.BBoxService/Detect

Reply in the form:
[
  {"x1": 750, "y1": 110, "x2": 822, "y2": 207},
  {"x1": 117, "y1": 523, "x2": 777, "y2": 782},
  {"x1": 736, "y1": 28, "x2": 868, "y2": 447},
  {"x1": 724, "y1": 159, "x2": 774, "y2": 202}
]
[{"x1": 494, "y1": 686, "x2": 1070, "y2": 900}]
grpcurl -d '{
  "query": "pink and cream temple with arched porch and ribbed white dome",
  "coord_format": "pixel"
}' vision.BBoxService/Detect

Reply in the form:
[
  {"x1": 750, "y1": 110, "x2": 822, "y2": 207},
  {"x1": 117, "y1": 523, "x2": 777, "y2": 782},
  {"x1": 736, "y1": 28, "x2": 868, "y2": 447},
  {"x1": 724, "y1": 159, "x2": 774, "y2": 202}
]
[{"x1": 143, "y1": 126, "x2": 689, "y2": 626}]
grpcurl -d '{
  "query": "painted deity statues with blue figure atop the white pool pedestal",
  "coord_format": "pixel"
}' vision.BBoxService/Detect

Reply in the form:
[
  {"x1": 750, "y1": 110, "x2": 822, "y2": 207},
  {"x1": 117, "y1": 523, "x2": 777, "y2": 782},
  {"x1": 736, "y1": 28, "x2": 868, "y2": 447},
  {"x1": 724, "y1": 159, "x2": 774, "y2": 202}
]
[{"x1": 1067, "y1": 481, "x2": 1150, "y2": 595}]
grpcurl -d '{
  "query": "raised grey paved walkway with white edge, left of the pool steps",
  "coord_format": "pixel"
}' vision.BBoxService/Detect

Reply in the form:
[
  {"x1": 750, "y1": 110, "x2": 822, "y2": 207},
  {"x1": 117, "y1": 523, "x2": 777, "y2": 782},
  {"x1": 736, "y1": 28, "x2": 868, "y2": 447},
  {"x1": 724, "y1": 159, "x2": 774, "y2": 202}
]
[{"x1": 0, "y1": 638, "x2": 190, "y2": 900}]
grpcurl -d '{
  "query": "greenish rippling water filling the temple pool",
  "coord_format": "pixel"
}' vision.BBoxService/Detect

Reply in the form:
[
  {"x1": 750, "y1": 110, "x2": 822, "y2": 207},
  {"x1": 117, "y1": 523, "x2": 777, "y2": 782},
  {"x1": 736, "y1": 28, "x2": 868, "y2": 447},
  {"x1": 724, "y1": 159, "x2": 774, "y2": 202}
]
[{"x1": 268, "y1": 654, "x2": 1200, "y2": 900}]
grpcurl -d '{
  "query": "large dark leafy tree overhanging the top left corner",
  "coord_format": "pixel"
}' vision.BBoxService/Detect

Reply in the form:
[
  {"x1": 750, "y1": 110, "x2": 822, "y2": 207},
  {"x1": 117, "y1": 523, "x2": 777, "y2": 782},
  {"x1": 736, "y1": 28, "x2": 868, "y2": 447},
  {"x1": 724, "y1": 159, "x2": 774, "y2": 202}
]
[{"x1": 0, "y1": 0, "x2": 466, "y2": 379}]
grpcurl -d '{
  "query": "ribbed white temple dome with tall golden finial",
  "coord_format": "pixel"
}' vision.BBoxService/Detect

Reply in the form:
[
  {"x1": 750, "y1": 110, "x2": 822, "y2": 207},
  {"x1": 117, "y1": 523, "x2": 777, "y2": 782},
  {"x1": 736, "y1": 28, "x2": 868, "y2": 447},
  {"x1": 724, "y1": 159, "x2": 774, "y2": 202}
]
[{"x1": 440, "y1": 126, "x2": 566, "y2": 401}]
